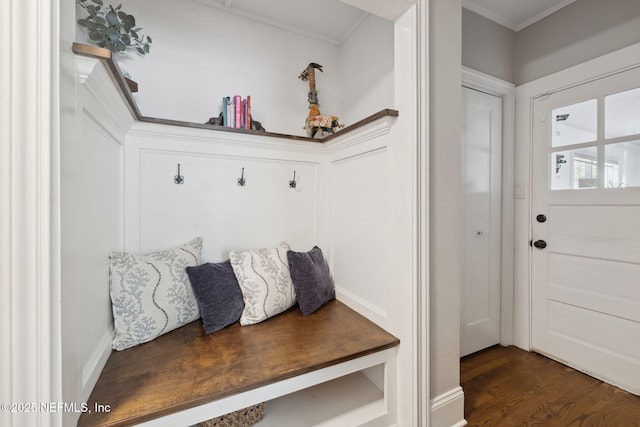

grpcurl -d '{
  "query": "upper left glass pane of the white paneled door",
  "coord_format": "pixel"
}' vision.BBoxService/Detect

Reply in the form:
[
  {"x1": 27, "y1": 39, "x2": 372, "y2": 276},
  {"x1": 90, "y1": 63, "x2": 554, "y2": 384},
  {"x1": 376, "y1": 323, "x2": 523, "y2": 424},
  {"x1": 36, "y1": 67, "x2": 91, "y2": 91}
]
[{"x1": 551, "y1": 99, "x2": 598, "y2": 147}]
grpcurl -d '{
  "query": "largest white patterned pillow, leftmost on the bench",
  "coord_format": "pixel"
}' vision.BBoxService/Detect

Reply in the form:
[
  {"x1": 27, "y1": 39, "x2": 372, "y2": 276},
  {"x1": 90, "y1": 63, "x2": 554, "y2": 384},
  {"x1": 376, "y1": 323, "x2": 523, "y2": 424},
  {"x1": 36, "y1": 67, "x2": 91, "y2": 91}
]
[{"x1": 109, "y1": 237, "x2": 202, "y2": 350}]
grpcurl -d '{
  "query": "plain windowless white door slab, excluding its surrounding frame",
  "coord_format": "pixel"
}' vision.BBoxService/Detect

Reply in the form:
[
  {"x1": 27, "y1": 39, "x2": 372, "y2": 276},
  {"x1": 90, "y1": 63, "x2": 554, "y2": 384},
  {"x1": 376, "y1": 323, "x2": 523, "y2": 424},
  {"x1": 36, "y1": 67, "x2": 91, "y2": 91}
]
[{"x1": 460, "y1": 87, "x2": 502, "y2": 356}]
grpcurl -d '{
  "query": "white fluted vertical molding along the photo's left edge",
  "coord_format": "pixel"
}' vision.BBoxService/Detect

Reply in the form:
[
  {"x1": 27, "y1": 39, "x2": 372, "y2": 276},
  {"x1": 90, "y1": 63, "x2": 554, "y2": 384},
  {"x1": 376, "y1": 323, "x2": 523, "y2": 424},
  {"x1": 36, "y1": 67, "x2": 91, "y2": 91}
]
[{"x1": 0, "y1": 0, "x2": 62, "y2": 426}]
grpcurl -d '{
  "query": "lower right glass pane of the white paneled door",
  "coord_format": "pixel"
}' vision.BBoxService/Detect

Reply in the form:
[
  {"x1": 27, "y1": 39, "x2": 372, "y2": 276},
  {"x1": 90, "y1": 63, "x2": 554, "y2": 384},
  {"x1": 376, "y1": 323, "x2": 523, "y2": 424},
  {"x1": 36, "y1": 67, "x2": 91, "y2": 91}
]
[{"x1": 604, "y1": 141, "x2": 640, "y2": 188}]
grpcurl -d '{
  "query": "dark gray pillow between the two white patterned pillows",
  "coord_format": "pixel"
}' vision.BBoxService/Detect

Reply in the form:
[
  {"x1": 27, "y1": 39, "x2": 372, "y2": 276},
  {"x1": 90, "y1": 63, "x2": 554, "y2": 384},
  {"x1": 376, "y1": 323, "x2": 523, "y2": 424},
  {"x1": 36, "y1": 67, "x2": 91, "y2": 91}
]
[{"x1": 186, "y1": 260, "x2": 244, "y2": 334}]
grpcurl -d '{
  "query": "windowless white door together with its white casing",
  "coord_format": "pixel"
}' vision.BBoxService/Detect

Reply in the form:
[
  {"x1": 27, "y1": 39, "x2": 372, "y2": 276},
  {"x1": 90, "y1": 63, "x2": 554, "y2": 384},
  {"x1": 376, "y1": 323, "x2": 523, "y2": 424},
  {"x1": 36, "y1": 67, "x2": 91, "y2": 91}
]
[{"x1": 460, "y1": 68, "x2": 515, "y2": 356}]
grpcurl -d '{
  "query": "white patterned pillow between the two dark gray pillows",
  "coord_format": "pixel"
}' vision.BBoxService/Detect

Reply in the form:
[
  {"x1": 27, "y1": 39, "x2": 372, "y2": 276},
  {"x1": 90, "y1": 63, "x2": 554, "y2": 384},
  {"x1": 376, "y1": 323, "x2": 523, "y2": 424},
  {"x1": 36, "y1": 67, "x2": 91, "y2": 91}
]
[{"x1": 229, "y1": 242, "x2": 296, "y2": 325}]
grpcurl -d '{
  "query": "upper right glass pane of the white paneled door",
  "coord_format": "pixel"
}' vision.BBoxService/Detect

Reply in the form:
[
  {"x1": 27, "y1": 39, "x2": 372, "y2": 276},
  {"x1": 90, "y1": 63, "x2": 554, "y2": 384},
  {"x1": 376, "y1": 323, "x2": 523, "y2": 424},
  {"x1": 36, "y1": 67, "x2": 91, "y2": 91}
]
[{"x1": 604, "y1": 88, "x2": 640, "y2": 138}]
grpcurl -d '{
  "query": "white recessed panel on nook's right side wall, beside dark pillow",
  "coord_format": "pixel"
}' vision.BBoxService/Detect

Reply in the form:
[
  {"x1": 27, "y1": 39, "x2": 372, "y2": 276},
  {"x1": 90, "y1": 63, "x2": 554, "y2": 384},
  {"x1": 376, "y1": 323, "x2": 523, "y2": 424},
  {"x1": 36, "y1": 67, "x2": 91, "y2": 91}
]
[{"x1": 330, "y1": 147, "x2": 392, "y2": 325}]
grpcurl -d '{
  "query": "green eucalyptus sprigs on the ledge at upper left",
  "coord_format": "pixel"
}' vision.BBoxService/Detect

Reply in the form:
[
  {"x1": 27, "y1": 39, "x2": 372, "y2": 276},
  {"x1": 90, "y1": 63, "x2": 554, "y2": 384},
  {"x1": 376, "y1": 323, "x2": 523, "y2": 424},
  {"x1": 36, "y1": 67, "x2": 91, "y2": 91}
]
[{"x1": 76, "y1": 0, "x2": 151, "y2": 55}]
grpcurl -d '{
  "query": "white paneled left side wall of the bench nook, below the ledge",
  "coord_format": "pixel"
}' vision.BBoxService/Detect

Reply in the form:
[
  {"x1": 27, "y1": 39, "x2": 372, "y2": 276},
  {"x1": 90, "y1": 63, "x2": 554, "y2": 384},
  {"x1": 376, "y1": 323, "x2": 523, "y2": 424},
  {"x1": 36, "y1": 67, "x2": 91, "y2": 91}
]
[{"x1": 60, "y1": 57, "x2": 133, "y2": 424}]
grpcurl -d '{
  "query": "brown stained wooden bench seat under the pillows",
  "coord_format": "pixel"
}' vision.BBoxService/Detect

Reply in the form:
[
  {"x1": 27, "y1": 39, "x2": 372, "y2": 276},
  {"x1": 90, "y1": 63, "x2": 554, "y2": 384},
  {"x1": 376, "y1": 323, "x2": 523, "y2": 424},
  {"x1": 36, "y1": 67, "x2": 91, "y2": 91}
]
[{"x1": 78, "y1": 300, "x2": 399, "y2": 426}]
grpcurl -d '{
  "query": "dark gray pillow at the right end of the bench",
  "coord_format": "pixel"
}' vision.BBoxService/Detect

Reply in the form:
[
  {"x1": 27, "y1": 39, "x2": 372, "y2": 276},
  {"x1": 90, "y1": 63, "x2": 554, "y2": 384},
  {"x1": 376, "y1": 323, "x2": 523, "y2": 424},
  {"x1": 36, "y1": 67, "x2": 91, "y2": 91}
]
[{"x1": 287, "y1": 246, "x2": 336, "y2": 316}]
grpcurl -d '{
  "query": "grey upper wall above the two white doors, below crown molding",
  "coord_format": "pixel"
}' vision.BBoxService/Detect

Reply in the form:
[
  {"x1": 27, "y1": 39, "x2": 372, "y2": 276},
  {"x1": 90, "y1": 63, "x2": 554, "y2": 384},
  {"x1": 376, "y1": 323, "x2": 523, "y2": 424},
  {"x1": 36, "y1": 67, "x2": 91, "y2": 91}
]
[{"x1": 462, "y1": 0, "x2": 640, "y2": 85}]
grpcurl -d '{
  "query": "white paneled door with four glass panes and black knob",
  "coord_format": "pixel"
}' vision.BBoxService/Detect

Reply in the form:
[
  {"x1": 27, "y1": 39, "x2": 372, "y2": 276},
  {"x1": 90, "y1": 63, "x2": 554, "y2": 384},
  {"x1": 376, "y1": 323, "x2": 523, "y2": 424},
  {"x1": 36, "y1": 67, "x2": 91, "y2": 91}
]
[{"x1": 531, "y1": 64, "x2": 640, "y2": 393}]
